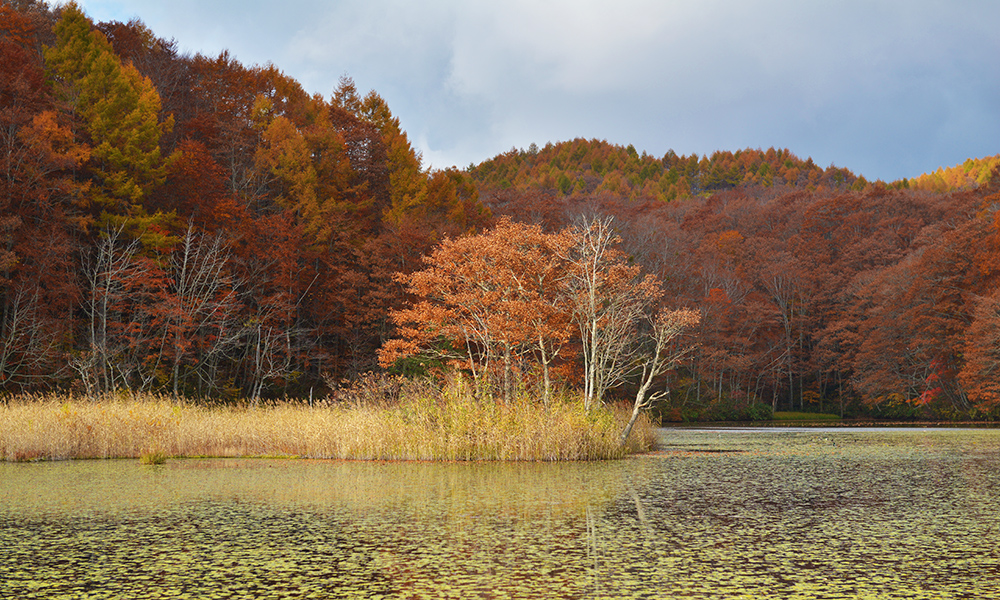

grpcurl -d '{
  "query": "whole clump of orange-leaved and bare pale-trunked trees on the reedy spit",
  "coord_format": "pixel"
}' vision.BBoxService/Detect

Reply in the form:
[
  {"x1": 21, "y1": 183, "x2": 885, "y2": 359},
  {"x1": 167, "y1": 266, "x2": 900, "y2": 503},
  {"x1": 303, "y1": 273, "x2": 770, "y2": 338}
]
[{"x1": 380, "y1": 213, "x2": 700, "y2": 439}]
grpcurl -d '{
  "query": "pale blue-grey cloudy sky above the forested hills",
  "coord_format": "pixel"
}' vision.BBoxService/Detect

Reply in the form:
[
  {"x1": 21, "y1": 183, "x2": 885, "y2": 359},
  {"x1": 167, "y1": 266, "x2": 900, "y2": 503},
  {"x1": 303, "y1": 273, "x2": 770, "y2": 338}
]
[{"x1": 72, "y1": 0, "x2": 1000, "y2": 181}]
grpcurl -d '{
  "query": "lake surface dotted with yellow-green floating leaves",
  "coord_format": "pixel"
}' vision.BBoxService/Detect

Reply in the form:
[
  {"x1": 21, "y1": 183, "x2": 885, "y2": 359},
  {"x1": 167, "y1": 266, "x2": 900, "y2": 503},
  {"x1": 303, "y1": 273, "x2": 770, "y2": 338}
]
[{"x1": 0, "y1": 429, "x2": 1000, "y2": 598}]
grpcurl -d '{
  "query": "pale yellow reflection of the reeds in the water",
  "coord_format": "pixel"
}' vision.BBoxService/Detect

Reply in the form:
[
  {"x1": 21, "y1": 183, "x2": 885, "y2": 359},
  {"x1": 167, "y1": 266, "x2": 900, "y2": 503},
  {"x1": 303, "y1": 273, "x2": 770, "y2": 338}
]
[{"x1": 0, "y1": 458, "x2": 636, "y2": 524}]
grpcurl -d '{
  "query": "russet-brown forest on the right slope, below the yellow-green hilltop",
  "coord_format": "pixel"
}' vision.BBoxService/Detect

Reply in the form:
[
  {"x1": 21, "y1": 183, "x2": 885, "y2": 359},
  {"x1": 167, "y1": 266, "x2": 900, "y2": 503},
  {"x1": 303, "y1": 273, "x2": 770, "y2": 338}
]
[{"x1": 484, "y1": 186, "x2": 1000, "y2": 418}]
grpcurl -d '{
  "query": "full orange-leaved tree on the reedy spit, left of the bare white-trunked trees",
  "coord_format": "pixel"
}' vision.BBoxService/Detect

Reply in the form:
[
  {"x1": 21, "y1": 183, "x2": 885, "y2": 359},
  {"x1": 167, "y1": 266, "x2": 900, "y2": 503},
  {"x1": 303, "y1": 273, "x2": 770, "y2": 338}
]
[{"x1": 380, "y1": 219, "x2": 571, "y2": 401}]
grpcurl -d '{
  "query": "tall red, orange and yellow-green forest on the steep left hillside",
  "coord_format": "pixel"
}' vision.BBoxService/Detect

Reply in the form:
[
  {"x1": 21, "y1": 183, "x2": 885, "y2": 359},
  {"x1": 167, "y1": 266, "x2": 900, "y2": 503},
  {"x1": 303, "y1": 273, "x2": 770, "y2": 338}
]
[{"x1": 0, "y1": 2, "x2": 489, "y2": 397}]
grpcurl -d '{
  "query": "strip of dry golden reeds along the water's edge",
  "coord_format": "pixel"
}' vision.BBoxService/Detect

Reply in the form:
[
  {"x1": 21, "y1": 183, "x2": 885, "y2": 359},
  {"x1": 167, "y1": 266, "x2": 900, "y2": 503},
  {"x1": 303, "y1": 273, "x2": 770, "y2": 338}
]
[{"x1": 0, "y1": 395, "x2": 653, "y2": 461}]
